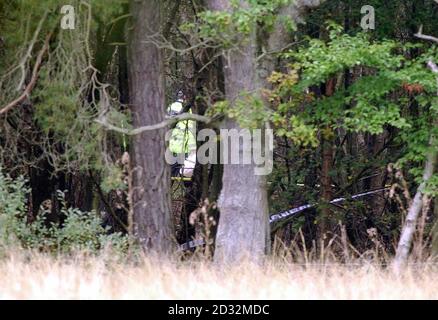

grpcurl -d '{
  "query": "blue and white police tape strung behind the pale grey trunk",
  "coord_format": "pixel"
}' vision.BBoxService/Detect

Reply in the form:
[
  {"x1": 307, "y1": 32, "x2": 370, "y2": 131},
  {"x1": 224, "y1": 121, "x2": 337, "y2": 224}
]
[{"x1": 178, "y1": 187, "x2": 390, "y2": 251}]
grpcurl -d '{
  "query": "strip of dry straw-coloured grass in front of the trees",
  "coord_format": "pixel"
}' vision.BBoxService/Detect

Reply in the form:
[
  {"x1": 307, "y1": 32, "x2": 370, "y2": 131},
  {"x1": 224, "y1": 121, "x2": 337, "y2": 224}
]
[{"x1": 0, "y1": 252, "x2": 438, "y2": 299}]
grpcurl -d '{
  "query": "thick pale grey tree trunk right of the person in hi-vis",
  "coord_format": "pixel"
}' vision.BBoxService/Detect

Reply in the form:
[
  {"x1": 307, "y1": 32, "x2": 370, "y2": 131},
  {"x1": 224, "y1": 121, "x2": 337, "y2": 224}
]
[{"x1": 203, "y1": 0, "x2": 321, "y2": 263}]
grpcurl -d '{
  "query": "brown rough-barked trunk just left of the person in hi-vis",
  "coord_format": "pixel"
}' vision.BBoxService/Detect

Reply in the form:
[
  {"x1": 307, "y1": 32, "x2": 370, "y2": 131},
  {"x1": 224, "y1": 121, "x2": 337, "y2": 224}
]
[{"x1": 128, "y1": 0, "x2": 174, "y2": 253}]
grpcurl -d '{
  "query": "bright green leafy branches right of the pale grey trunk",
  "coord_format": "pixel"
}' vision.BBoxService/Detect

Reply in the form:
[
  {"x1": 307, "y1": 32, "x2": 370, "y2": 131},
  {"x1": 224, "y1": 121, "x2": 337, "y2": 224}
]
[{"x1": 270, "y1": 25, "x2": 435, "y2": 145}]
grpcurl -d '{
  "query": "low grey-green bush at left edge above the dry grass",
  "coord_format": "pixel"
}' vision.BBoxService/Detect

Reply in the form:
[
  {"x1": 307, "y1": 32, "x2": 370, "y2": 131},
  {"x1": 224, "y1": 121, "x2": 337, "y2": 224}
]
[{"x1": 0, "y1": 171, "x2": 128, "y2": 253}]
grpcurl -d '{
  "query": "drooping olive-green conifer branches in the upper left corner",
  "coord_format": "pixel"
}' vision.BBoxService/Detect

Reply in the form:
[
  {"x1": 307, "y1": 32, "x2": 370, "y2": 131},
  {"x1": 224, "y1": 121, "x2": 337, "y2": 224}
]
[{"x1": 0, "y1": 0, "x2": 129, "y2": 188}]
